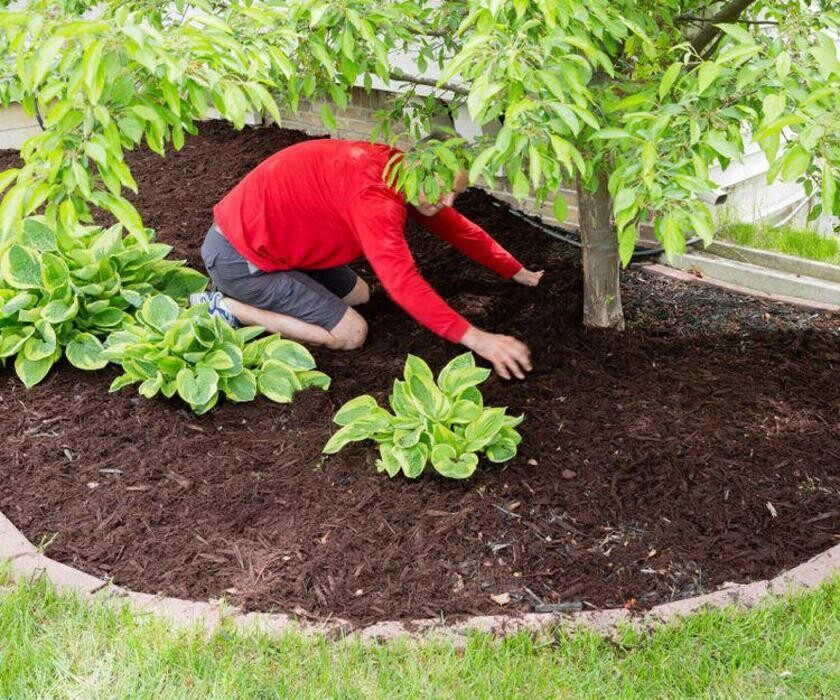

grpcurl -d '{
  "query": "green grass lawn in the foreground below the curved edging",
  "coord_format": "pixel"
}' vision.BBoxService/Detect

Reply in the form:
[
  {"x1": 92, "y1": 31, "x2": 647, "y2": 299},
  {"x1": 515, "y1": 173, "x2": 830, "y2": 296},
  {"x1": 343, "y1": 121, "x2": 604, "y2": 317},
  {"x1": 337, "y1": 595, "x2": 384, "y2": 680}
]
[{"x1": 0, "y1": 572, "x2": 840, "y2": 700}]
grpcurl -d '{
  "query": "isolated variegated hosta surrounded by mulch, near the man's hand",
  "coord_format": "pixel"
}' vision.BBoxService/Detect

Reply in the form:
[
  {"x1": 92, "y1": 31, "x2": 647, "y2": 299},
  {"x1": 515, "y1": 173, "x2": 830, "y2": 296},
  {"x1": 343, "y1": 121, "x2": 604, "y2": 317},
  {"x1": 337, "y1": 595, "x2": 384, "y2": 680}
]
[{"x1": 324, "y1": 352, "x2": 522, "y2": 479}]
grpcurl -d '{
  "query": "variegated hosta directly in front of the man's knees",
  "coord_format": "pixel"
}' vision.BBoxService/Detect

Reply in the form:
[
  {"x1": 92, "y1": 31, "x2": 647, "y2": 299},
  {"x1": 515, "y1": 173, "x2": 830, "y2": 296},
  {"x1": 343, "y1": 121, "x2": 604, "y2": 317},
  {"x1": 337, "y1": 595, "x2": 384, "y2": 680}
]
[{"x1": 100, "y1": 294, "x2": 330, "y2": 415}]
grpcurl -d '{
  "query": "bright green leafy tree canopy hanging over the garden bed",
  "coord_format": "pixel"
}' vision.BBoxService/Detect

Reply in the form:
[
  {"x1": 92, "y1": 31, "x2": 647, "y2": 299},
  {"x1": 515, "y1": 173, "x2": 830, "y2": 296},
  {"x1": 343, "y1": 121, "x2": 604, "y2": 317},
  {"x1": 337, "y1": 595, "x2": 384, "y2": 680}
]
[{"x1": 0, "y1": 0, "x2": 840, "y2": 296}]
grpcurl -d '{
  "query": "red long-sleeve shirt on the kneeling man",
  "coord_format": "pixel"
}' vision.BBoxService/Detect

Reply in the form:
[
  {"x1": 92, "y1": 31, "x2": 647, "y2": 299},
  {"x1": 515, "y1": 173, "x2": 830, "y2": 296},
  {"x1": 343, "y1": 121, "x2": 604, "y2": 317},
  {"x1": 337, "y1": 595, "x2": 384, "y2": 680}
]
[{"x1": 213, "y1": 139, "x2": 522, "y2": 343}]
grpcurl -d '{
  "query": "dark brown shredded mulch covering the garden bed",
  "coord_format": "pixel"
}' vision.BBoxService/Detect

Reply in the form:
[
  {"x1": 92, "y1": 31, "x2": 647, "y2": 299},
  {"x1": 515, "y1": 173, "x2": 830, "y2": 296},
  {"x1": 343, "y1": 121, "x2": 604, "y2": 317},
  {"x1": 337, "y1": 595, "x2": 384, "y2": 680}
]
[{"x1": 0, "y1": 124, "x2": 840, "y2": 623}]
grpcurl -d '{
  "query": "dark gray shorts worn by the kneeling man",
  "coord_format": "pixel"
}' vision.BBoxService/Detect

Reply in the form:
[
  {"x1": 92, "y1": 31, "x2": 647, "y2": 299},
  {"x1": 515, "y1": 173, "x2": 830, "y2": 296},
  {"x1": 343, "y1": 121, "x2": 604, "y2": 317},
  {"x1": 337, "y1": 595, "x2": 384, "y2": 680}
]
[{"x1": 201, "y1": 225, "x2": 358, "y2": 331}]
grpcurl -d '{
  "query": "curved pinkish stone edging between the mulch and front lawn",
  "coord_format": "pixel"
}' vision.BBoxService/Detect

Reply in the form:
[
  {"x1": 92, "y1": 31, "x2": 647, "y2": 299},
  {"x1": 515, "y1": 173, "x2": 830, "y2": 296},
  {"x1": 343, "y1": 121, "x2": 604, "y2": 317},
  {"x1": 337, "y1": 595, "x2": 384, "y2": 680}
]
[{"x1": 0, "y1": 513, "x2": 840, "y2": 643}]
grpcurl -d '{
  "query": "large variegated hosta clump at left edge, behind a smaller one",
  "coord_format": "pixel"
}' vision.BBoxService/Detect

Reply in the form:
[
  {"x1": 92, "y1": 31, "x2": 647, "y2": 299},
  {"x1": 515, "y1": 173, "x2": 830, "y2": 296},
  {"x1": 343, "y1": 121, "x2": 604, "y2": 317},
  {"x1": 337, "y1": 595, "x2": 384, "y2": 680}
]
[{"x1": 0, "y1": 216, "x2": 207, "y2": 387}]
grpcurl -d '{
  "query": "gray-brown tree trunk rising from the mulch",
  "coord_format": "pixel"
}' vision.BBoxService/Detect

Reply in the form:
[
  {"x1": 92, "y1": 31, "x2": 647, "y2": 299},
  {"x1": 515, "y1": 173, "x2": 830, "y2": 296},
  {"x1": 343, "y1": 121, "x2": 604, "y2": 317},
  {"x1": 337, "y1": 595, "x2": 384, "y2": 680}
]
[{"x1": 577, "y1": 173, "x2": 624, "y2": 331}]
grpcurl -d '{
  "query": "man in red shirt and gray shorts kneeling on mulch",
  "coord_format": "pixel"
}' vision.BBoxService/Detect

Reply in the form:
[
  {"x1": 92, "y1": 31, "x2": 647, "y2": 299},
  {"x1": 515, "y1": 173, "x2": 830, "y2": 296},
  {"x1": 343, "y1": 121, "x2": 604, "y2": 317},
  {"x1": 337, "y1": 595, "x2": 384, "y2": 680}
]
[{"x1": 190, "y1": 139, "x2": 542, "y2": 379}]
